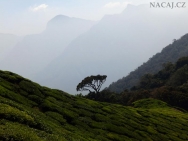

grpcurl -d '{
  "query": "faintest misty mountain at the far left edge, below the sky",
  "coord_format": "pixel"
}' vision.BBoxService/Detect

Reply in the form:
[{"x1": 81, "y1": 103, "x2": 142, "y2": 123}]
[{"x1": 0, "y1": 33, "x2": 22, "y2": 61}]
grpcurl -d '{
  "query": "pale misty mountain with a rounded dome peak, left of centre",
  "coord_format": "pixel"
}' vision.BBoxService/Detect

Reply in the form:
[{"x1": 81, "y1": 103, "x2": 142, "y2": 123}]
[{"x1": 1, "y1": 15, "x2": 95, "y2": 78}]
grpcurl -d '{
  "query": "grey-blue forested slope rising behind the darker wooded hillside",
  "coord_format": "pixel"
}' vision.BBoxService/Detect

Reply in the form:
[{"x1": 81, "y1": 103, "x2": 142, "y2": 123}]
[{"x1": 108, "y1": 34, "x2": 188, "y2": 93}]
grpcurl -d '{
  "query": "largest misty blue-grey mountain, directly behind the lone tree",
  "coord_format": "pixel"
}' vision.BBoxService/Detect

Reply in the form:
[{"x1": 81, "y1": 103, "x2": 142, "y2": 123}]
[{"x1": 34, "y1": 5, "x2": 188, "y2": 93}]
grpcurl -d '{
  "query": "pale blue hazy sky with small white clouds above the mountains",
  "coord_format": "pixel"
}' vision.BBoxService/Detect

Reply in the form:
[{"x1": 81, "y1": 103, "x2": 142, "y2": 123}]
[{"x1": 0, "y1": 0, "x2": 153, "y2": 35}]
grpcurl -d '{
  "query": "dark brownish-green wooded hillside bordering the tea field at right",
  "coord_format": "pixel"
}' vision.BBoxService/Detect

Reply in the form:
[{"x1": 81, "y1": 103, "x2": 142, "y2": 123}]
[{"x1": 86, "y1": 56, "x2": 188, "y2": 110}]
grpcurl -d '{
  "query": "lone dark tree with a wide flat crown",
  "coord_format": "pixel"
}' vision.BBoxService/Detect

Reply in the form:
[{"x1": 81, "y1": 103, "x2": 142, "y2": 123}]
[{"x1": 76, "y1": 75, "x2": 107, "y2": 93}]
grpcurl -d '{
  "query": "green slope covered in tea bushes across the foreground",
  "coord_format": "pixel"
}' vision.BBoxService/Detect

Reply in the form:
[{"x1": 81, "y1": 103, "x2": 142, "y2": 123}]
[{"x1": 0, "y1": 71, "x2": 188, "y2": 141}]
